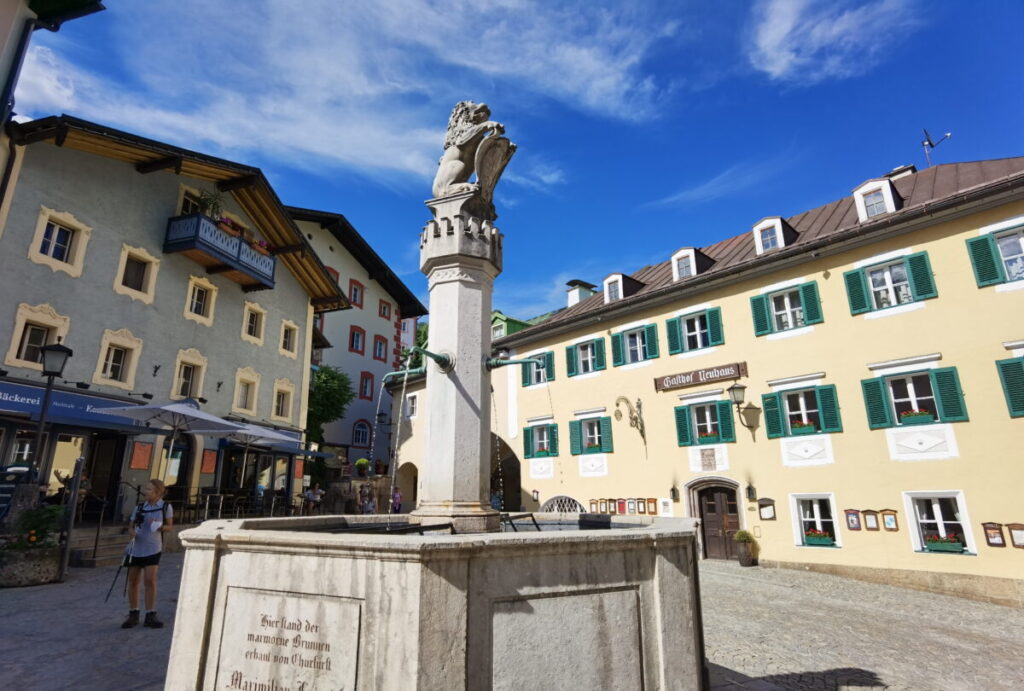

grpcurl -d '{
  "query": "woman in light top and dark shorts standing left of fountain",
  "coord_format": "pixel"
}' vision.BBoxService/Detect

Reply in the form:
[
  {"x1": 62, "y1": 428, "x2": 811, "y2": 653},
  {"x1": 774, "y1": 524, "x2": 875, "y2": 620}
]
[{"x1": 121, "y1": 479, "x2": 174, "y2": 629}]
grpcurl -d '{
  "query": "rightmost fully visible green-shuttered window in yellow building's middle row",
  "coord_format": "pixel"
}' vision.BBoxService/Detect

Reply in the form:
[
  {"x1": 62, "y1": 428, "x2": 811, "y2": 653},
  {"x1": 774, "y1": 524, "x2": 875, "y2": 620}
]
[{"x1": 860, "y1": 368, "x2": 968, "y2": 429}]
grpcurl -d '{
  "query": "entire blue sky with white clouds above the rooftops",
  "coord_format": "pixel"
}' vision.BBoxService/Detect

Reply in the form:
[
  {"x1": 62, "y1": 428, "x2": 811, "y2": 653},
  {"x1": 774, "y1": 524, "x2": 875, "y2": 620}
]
[{"x1": 16, "y1": 0, "x2": 1024, "y2": 317}]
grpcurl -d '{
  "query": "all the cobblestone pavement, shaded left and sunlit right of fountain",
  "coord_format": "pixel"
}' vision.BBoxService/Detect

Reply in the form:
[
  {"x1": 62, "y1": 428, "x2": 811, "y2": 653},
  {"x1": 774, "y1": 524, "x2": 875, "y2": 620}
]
[{"x1": 0, "y1": 554, "x2": 1024, "y2": 691}]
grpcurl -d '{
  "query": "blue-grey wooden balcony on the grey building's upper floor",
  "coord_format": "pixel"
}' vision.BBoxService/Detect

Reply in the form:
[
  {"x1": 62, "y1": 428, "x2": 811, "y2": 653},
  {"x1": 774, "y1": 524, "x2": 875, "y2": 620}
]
[{"x1": 164, "y1": 214, "x2": 278, "y2": 292}]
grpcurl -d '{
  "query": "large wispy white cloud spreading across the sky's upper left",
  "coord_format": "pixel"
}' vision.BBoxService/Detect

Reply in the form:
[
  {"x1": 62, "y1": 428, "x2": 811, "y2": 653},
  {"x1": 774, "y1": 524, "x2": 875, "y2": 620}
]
[{"x1": 16, "y1": 0, "x2": 675, "y2": 188}]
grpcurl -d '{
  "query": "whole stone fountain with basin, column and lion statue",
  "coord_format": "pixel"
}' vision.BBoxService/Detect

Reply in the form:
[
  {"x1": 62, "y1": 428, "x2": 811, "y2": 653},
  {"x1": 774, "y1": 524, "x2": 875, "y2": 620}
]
[{"x1": 166, "y1": 101, "x2": 706, "y2": 691}]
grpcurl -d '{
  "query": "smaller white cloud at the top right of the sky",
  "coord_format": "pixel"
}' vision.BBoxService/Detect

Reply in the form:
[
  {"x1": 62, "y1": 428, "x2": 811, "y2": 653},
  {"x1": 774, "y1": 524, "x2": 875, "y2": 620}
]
[{"x1": 748, "y1": 0, "x2": 920, "y2": 85}]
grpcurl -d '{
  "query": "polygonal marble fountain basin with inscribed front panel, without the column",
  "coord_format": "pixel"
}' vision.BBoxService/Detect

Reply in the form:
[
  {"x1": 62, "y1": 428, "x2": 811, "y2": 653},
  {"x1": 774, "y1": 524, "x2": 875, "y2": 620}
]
[{"x1": 167, "y1": 514, "x2": 703, "y2": 691}]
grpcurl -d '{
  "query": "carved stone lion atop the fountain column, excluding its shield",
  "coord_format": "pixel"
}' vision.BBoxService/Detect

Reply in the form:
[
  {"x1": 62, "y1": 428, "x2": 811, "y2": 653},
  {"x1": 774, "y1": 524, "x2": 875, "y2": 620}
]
[{"x1": 433, "y1": 100, "x2": 505, "y2": 198}]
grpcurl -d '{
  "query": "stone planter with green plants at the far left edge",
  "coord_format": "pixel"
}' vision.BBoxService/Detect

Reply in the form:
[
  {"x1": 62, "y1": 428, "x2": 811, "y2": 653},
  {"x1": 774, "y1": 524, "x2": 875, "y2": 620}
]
[{"x1": 0, "y1": 506, "x2": 65, "y2": 588}]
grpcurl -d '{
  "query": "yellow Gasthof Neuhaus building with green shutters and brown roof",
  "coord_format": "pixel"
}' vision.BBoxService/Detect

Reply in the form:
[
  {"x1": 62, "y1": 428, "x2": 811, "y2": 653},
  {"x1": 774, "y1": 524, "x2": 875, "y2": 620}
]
[{"x1": 395, "y1": 158, "x2": 1024, "y2": 606}]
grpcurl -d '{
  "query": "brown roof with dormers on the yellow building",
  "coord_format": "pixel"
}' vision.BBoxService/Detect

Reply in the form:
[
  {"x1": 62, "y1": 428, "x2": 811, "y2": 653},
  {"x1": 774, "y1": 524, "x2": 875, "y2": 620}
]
[{"x1": 501, "y1": 157, "x2": 1024, "y2": 341}]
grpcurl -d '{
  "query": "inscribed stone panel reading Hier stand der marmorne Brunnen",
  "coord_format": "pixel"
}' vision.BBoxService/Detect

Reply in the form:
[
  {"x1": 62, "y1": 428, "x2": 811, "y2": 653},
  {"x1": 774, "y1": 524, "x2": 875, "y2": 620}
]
[{"x1": 215, "y1": 588, "x2": 359, "y2": 691}]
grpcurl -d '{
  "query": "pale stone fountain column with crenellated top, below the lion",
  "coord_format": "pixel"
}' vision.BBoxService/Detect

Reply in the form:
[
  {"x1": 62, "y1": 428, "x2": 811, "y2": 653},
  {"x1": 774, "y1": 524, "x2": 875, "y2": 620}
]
[{"x1": 413, "y1": 191, "x2": 502, "y2": 532}]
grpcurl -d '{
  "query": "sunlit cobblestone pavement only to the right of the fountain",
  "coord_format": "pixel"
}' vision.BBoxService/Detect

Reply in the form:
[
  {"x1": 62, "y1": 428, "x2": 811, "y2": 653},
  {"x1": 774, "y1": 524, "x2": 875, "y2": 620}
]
[{"x1": 700, "y1": 561, "x2": 1024, "y2": 691}]
